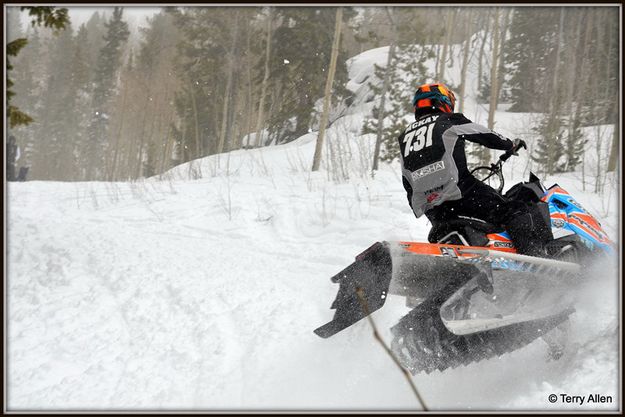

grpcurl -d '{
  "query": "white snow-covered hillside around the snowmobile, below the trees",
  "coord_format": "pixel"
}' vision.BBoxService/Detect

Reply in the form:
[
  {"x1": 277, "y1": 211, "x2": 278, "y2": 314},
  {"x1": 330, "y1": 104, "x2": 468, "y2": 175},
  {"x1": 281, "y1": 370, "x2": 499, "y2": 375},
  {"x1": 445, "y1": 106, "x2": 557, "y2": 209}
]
[{"x1": 6, "y1": 39, "x2": 621, "y2": 411}]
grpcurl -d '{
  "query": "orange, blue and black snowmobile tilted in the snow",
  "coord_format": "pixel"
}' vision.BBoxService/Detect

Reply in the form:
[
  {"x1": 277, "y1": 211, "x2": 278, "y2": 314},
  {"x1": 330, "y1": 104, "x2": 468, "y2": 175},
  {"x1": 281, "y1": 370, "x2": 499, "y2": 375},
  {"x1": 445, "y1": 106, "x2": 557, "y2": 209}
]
[{"x1": 315, "y1": 147, "x2": 615, "y2": 375}]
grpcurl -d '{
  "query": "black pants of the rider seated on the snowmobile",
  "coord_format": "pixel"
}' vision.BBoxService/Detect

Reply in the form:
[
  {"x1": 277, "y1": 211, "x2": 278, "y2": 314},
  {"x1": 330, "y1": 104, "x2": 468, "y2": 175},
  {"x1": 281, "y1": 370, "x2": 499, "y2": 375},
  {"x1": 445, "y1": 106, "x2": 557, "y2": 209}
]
[{"x1": 425, "y1": 180, "x2": 553, "y2": 256}]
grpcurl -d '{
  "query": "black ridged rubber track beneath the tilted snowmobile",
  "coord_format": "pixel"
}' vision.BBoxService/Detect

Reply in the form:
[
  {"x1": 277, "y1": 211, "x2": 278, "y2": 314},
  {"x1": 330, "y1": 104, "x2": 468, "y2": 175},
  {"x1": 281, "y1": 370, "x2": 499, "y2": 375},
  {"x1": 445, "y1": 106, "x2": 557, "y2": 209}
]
[{"x1": 391, "y1": 284, "x2": 574, "y2": 375}]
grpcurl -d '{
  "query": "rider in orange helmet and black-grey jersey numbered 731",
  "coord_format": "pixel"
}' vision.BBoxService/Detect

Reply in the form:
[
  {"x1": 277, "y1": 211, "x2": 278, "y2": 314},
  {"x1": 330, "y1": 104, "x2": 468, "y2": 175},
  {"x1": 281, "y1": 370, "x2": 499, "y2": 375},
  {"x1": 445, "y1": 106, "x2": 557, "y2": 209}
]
[{"x1": 398, "y1": 83, "x2": 552, "y2": 256}]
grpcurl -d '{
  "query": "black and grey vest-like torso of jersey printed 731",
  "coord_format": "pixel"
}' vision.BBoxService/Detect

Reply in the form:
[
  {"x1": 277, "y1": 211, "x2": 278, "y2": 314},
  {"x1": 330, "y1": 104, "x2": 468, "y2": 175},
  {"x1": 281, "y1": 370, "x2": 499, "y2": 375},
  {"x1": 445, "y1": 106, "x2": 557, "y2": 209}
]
[{"x1": 399, "y1": 114, "x2": 462, "y2": 217}]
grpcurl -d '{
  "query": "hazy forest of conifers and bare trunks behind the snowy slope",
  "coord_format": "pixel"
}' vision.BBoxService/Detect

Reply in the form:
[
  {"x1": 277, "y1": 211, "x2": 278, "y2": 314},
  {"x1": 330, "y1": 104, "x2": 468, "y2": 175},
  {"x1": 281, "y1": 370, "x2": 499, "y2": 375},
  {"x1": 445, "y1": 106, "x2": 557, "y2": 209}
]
[{"x1": 5, "y1": 6, "x2": 620, "y2": 181}]
